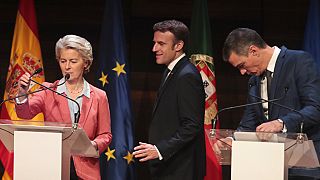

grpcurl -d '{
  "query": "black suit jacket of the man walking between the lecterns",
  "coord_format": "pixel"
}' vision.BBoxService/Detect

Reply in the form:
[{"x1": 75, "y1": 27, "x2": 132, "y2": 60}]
[{"x1": 149, "y1": 57, "x2": 206, "y2": 180}]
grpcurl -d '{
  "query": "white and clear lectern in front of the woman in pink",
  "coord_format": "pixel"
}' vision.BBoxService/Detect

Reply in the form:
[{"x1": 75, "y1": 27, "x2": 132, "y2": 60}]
[{"x1": 0, "y1": 120, "x2": 99, "y2": 180}]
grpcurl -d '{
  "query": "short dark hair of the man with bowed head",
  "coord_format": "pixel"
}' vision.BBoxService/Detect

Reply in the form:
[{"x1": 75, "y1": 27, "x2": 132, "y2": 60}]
[{"x1": 223, "y1": 28, "x2": 267, "y2": 61}]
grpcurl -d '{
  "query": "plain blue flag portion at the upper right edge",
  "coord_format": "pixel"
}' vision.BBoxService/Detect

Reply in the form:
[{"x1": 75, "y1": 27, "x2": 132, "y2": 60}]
[{"x1": 303, "y1": 0, "x2": 320, "y2": 68}]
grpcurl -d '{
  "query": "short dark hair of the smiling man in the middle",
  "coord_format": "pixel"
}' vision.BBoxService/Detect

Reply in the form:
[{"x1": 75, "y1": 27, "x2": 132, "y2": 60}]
[{"x1": 153, "y1": 20, "x2": 189, "y2": 51}]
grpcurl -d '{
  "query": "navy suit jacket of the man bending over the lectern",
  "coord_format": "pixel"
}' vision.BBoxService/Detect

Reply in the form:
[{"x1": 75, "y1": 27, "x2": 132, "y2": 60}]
[{"x1": 238, "y1": 47, "x2": 320, "y2": 158}]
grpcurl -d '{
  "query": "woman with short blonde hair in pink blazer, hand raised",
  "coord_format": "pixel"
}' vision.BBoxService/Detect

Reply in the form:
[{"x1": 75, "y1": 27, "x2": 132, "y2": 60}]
[{"x1": 16, "y1": 35, "x2": 112, "y2": 180}]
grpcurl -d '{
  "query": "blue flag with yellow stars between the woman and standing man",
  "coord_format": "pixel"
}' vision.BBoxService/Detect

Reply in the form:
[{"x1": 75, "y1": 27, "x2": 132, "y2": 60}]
[{"x1": 97, "y1": 0, "x2": 135, "y2": 180}]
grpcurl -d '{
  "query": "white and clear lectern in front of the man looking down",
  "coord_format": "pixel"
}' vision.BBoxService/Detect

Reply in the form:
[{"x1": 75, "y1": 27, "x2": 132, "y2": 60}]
[{"x1": 206, "y1": 129, "x2": 320, "y2": 180}]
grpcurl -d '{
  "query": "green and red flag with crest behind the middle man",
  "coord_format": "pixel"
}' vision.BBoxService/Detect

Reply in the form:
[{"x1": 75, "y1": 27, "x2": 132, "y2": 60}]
[{"x1": 189, "y1": 0, "x2": 222, "y2": 180}]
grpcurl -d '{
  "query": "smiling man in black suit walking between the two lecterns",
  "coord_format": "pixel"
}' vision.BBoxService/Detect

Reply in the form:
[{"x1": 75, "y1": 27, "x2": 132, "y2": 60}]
[{"x1": 133, "y1": 20, "x2": 206, "y2": 180}]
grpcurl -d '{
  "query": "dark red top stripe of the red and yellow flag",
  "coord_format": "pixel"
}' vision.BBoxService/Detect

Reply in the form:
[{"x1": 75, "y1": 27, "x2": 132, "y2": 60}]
[{"x1": 19, "y1": 0, "x2": 39, "y2": 39}]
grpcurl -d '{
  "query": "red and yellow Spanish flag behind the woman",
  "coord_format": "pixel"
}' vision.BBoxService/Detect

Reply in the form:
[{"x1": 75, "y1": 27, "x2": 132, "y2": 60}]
[{"x1": 0, "y1": 0, "x2": 44, "y2": 180}]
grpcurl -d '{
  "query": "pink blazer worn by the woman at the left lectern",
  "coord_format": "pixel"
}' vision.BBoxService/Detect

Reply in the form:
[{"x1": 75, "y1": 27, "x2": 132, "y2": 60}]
[{"x1": 16, "y1": 81, "x2": 112, "y2": 180}]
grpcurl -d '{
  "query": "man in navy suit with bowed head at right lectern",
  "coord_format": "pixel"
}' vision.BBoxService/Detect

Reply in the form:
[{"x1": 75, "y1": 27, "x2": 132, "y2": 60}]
[{"x1": 223, "y1": 28, "x2": 320, "y2": 179}]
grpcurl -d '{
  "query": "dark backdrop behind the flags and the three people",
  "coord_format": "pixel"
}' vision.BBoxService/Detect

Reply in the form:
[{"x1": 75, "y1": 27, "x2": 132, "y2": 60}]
[{"x1": 0, "y1": 0, "x2": 309, "y2": 179}]
